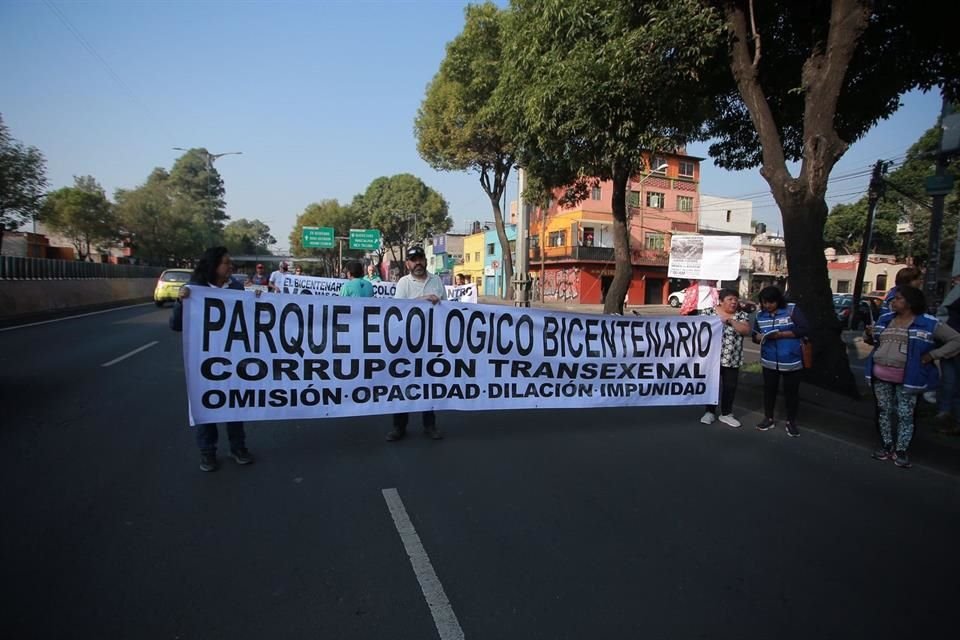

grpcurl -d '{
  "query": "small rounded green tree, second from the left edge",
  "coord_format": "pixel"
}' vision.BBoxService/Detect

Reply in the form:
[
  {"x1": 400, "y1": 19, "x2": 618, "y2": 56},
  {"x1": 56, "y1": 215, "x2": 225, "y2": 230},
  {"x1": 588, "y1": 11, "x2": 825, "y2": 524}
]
[{"x1": 40, "y1": 176, "x2": 120, "y2": 260}]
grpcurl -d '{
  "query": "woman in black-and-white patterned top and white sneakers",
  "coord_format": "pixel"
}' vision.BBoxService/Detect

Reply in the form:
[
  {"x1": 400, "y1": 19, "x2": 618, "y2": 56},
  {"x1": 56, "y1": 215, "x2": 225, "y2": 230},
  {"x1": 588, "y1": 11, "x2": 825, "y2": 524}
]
[{"x1": 700, "y1": 289, "x2": 750, "y2": 428}]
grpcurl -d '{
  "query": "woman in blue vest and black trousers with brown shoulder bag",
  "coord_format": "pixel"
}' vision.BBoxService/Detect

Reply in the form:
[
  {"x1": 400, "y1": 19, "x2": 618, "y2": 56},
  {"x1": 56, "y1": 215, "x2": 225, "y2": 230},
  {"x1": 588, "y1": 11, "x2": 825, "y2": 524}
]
[{"x1": 753, "y1": 286, "x2": 807, "y2": 438}]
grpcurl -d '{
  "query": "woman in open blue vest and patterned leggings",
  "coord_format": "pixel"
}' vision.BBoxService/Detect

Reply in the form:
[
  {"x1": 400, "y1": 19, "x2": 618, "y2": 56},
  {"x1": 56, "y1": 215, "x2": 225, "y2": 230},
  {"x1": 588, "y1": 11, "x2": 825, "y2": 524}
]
[{"x1": 865, "y1": 286, "x2": 960, "y2": 469}]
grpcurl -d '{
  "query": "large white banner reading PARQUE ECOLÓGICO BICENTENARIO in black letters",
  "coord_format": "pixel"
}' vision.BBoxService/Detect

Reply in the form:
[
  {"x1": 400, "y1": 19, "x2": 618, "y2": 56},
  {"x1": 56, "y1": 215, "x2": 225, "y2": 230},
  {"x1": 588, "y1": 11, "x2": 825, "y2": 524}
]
[{"x1": 183, "y1": 287, "x2": 722, "y2": 423}]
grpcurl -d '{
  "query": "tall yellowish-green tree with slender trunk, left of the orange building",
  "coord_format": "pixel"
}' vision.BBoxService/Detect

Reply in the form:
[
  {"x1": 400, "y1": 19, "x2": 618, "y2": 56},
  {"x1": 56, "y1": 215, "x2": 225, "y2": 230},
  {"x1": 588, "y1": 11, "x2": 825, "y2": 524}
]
[{"x1": 414, "y1": 2, "x2": 514, "y2": 297}]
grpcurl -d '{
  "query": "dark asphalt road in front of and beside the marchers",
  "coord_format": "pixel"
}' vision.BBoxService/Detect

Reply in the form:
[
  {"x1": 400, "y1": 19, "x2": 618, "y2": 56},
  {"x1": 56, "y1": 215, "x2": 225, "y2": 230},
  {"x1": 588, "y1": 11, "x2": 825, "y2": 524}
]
[{"x1": 0, "y1": 306, "x2": 960, "y2": 640}]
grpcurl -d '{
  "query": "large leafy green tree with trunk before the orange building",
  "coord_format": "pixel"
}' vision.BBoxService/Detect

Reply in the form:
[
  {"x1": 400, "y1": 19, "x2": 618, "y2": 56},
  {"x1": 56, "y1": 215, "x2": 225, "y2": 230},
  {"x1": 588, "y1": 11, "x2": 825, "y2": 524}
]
[{"x1": 501, "y1": 0, "x2": 722, "y2": 313}]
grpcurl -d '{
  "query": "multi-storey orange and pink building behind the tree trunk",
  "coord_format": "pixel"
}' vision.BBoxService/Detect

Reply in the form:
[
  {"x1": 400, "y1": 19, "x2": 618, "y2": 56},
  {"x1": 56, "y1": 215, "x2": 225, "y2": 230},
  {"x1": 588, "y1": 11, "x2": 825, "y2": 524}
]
[{"x1": 530, "y1": 153, "x2": 703, "y2": 305}]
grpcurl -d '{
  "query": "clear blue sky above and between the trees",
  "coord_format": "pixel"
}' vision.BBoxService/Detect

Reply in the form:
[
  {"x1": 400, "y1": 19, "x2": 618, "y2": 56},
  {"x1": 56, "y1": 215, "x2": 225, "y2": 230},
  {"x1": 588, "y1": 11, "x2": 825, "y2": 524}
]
[{"x1": 0, "y1": 0, "x2": 940, "y2": 248}]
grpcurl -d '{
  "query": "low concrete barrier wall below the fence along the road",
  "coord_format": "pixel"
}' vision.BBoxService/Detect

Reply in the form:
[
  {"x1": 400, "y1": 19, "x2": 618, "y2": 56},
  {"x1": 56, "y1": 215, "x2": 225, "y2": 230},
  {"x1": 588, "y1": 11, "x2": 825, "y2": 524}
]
[{"x1": 0, "y1": 278, "x2": 157, "y2": 319}]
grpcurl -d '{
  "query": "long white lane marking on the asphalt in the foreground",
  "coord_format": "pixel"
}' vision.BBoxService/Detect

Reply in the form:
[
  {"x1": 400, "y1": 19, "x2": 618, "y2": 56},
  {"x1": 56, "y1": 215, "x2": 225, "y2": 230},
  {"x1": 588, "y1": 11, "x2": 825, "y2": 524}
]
[{"x1": 383, "y1": 489, "x2": 464, "y2": 640}]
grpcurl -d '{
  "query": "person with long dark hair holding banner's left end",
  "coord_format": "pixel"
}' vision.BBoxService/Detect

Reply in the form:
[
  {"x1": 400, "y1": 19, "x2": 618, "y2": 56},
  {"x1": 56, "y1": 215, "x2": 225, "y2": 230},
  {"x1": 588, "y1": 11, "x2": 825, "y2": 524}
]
[{"x1": 170, "y1": 247, "x2": 253, "y2": 471}]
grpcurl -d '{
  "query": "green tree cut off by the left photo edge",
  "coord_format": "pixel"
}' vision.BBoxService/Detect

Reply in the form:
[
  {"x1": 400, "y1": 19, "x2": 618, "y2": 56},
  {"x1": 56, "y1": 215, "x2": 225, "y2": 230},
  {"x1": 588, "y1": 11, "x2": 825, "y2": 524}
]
[{"x1": 0, "y1": 116, "x2": 47, "y2": 245}]
